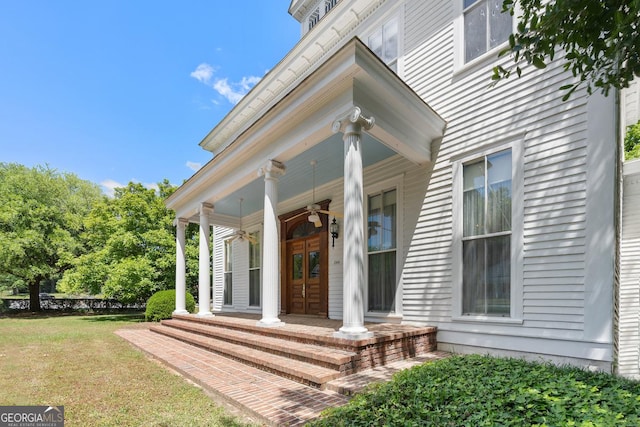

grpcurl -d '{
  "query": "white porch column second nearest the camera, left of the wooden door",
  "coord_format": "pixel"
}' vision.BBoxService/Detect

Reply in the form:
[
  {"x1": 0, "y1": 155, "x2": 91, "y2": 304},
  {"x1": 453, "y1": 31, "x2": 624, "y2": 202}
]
[{"x1": 258, "y1": 160, "x2": 285, "y2": 327}]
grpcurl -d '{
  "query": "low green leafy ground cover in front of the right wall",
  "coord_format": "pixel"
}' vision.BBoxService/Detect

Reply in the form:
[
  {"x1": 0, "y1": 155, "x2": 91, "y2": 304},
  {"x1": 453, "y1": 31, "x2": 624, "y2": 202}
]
[{"x1": 309, "y1": 355, "x2": 640, "y2": 427}]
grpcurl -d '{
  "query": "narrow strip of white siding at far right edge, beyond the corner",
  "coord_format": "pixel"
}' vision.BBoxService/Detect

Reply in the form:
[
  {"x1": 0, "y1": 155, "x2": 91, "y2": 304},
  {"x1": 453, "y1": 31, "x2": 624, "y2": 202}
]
[{"x1": 618, "y1": 160, "x2": 640, "y2": 378}]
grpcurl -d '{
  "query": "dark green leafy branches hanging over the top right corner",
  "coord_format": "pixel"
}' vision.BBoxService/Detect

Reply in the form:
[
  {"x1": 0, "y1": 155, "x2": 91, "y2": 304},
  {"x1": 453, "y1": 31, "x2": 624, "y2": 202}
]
[{"x1": 492, "y1": 0, "x2": 640, "y2": 100}]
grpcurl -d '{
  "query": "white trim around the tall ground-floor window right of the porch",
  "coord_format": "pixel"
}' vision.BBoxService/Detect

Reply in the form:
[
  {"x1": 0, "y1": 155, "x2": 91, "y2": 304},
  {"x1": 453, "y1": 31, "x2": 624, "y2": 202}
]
[{"x1": 451, "y1": 133, "x2": 525, "y2": 324}]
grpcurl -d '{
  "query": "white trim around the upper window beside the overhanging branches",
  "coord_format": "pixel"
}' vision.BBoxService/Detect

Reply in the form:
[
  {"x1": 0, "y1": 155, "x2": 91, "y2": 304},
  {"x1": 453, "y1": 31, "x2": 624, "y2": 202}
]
[{"x1": 453, "y1": 0, "x2": 520, "y2": 76}]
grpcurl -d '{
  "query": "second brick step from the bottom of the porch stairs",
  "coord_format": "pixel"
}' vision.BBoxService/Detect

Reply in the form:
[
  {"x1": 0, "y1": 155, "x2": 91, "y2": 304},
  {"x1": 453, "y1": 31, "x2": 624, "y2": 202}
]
[{"x1": 162, "y1": 319, "x2": 357, "y2": 374}]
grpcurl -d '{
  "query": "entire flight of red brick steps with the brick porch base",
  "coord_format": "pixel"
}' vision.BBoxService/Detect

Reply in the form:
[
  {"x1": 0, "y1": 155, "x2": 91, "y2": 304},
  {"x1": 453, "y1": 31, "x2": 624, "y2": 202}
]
[{"x1": 149, "y1": 315, "x2": 436, "y2": 390}]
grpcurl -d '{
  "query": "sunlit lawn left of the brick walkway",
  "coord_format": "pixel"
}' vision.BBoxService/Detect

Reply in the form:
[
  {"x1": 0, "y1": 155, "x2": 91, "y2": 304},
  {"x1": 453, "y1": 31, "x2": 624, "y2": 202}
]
[{"x1": 0, "y1": 314, "x2": 258, "y2": 427}]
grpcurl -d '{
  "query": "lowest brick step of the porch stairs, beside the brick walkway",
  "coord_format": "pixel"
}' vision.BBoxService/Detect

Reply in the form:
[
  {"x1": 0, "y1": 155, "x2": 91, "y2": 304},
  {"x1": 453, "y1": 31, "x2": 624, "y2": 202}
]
[{"x1": 149, "y1": 324, "x2": 343, "y2": 389}]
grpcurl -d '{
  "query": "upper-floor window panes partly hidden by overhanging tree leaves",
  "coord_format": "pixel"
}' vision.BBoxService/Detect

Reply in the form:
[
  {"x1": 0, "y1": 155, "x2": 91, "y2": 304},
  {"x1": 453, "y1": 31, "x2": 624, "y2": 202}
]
[{"x1": 463, "y1": 0, "x2": 512, "y2": 62}]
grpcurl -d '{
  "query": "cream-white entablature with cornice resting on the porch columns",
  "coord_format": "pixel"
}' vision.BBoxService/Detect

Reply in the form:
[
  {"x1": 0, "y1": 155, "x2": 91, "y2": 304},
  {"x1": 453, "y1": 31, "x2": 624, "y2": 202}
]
[{"x1": 167, "y1": 38, "x2": 446, "y2": 222}]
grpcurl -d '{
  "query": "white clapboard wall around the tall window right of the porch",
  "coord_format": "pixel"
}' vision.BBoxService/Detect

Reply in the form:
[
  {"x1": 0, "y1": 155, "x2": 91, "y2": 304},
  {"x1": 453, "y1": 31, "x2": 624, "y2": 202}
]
[{"x1": 403, "y1": 0, "x2": 615, "y2": 366}]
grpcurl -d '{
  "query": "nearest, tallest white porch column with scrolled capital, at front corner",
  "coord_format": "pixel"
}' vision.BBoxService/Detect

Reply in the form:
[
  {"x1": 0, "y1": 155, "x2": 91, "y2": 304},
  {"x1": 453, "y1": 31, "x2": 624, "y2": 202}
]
[{"x1": 333, "y1": 107, "x2": 374, "y2": 340}]
